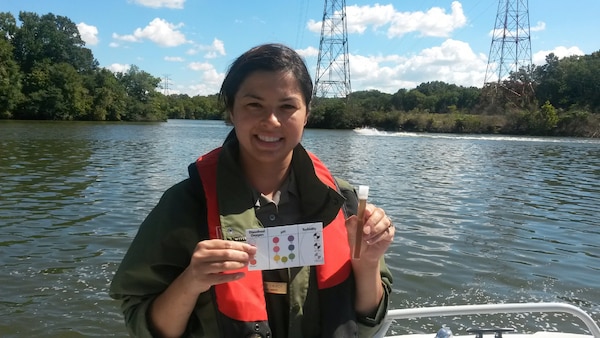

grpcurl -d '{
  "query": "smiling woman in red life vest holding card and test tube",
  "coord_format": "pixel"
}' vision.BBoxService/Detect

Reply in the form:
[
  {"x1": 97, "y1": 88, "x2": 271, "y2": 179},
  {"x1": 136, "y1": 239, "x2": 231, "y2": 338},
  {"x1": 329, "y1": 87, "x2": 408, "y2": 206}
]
[{"x1": 110, "y1": 44, "x2": 395, "y2": 337}]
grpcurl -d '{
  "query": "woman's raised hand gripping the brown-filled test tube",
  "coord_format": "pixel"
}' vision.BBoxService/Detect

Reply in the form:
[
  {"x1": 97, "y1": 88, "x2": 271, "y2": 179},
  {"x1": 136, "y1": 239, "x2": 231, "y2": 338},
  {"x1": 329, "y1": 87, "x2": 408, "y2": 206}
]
[{"x1": 346, "y1": 204, "x2": 395, "y2": 263}]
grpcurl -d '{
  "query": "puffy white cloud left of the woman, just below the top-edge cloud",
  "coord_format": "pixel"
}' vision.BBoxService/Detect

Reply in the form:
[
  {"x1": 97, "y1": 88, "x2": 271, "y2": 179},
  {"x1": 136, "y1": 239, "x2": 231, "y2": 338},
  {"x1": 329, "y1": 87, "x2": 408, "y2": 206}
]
[{"x1": 112, "y1": 18, "x2": 188, "y2": 47}]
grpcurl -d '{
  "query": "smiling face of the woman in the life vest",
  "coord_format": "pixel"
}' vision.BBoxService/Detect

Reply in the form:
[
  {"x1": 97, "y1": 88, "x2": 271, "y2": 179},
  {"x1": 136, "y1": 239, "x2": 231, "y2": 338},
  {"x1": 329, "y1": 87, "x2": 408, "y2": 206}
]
[{"x1": 230, "y1": 71, "x2": 308, "y2": 166}]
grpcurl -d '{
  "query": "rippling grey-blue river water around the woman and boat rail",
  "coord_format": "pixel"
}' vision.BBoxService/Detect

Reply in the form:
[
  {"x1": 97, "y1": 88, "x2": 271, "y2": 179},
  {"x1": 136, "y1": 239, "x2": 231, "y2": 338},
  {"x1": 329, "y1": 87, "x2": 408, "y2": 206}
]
[{"x1": 0, "y1": 120, "x2": 600, "y2": 337}]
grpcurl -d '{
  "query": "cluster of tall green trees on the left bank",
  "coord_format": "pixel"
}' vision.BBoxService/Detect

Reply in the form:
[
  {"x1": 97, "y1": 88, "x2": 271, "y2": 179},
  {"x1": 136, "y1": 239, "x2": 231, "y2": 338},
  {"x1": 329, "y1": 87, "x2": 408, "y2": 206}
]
[{"x1": 0, "y1": 12, "x2": 167, "y2": 121}]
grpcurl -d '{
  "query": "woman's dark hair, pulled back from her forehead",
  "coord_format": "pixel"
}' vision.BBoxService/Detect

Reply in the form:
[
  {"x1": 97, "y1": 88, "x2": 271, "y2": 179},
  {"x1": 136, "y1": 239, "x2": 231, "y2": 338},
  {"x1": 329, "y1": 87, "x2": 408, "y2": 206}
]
[{"x1": 219, "y1": 43, "x2": 313, "y2": 118}]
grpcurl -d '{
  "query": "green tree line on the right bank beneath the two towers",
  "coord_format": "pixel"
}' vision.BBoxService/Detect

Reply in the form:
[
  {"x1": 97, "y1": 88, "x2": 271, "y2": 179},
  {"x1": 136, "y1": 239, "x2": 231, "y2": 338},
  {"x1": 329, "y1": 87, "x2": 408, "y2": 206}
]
[{"x1": 308, "y1": 51, "x2": 600, "y2": 137}]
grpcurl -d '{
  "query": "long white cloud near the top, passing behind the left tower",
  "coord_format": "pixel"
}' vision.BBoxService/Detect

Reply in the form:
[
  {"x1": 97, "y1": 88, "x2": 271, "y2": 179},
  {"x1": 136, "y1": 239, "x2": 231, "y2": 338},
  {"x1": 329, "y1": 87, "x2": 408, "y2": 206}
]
[{"x1": 306, "y1": 1, "x2": 467, "y2": 39}]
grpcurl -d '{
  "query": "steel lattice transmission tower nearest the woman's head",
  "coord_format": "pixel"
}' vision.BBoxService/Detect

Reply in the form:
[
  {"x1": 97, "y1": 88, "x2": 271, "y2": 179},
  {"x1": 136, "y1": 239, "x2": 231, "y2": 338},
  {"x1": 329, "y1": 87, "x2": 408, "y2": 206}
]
[{"x1": 313, "y1": 0, "x2": 350, "y2": 98}]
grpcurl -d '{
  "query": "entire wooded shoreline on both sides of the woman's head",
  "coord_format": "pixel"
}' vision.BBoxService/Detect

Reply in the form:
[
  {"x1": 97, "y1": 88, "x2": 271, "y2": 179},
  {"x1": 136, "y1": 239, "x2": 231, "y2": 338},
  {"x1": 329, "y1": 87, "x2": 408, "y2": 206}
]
[{"x1": 0, "y1": 12, "x2": 600, "y2": 137}]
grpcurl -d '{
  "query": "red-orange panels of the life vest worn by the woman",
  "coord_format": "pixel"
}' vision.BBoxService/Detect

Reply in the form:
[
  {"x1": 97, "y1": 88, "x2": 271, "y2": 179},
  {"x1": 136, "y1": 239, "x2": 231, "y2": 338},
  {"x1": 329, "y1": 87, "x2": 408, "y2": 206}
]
[{"x1": 196, "y1": 148, "x2": 352, "y2": 322}]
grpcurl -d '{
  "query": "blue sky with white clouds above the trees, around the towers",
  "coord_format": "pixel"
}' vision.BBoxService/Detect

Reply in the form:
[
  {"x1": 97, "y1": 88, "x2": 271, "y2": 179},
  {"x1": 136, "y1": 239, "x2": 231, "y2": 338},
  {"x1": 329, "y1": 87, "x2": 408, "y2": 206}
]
[{"x1": 0, "y1": 0, "x2": 600, "y2": 96}]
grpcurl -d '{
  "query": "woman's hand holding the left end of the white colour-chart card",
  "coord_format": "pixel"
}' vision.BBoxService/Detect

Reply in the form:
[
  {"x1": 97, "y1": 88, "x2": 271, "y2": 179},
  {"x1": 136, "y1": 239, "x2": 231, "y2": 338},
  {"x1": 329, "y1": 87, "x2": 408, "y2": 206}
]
[{"x1": 184, "y1": 239, "x2": 256, "y2": 293}]
